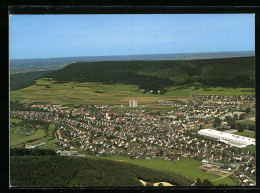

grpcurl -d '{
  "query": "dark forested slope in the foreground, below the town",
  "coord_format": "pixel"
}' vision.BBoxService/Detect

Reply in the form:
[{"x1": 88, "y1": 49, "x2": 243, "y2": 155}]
[{"x1": 10, "y1": 156, "x2": 192, "y2": 187}]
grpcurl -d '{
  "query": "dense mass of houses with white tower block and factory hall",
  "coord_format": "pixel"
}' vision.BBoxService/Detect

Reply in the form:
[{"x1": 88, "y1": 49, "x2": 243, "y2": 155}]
[{"x1": 10, "y1": 95, "x2": 255, "y2": 186}]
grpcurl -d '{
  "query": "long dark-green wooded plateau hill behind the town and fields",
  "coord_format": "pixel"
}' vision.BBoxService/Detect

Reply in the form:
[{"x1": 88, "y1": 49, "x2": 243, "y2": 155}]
[{"x1": 45, "y1": 57, "x2": 255, "y2": 90}]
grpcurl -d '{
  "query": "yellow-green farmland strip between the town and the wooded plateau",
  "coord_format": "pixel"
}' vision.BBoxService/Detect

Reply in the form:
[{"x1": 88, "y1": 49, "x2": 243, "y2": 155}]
[{"x1": 10, "y1": 79, "x2": 255, "y2": 106}]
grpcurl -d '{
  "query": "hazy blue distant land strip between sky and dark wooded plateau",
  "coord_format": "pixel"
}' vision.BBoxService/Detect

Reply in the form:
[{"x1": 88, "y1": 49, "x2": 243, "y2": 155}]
[{"x1": 10, "y1": 51, "x2": 255, "y2": 73}]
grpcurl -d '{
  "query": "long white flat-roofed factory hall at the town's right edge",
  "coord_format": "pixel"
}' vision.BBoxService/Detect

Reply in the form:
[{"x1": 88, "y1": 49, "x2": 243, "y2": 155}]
[{"x1": 198, "y1": 129, "x2": 255, "y2": 148}]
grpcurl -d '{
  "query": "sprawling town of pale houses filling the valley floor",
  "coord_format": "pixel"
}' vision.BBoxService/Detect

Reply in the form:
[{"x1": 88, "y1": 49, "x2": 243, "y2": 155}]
[{"x1": 10, "y1": 95, "x2": 256, "y2": 186}]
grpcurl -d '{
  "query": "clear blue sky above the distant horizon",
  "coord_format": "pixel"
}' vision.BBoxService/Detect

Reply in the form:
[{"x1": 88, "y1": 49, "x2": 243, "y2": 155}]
[{"x1": 9, "y1": 14, "x2": 255, "y2": 59}]
